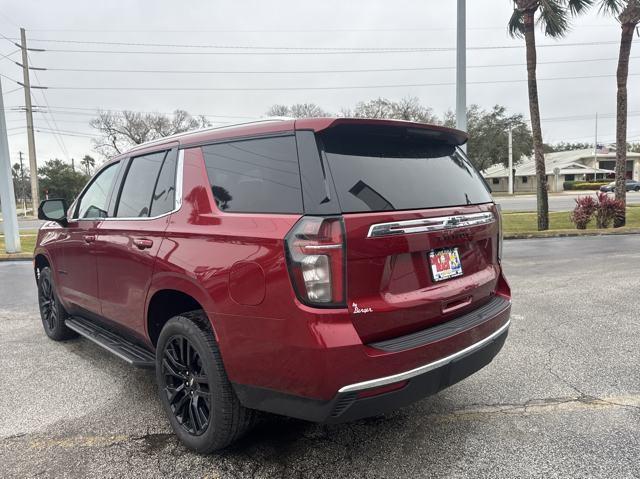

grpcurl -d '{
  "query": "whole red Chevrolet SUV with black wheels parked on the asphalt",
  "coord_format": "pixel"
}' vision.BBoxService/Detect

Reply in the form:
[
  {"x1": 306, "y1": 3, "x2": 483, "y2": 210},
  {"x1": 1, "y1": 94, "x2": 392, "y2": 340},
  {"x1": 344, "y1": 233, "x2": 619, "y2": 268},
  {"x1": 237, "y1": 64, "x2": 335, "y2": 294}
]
[{"x1": 34, "y1": 118, "x2": 511, "y2": 452}]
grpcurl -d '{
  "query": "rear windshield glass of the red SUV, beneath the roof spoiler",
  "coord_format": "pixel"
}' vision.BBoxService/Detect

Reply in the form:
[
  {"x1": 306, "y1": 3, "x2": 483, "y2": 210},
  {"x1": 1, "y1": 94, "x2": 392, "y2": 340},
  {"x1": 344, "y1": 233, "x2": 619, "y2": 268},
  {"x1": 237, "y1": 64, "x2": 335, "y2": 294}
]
[{"x1": 318, "y1": 125, "x2": 492, "y2": 213}]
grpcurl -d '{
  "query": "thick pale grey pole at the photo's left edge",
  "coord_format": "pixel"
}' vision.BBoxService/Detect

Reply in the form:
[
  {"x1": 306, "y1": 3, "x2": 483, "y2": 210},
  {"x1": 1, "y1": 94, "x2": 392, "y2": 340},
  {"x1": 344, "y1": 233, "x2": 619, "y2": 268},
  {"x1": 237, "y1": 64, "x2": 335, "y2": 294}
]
[{"x1": 0, "y1": 77, "x2": 22, "y2": 253}]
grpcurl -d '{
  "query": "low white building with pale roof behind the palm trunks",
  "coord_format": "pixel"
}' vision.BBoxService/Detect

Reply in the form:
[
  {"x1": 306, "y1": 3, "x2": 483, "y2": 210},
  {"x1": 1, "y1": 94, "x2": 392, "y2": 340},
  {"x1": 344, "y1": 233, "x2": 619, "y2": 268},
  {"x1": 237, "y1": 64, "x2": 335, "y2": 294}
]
[{"x1": 482, "y1": 149, "x2": 640, "y2": 193}]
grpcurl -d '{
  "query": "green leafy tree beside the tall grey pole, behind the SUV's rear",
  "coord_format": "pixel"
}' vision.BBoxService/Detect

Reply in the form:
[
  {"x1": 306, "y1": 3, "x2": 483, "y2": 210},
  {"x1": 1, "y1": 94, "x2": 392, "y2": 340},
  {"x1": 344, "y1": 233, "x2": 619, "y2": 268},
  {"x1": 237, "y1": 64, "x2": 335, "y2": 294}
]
[{"x1": 444, "y1": 105, "x2": 533, "y2": 171}]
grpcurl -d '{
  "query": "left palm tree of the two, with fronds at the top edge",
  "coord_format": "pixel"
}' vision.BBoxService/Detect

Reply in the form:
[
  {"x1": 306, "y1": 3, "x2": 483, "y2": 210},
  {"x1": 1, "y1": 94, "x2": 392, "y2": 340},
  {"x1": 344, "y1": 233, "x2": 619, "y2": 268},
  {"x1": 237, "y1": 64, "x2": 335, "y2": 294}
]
[{"x1": 508, "y1": 0, "x2": 593, "y2": 231}]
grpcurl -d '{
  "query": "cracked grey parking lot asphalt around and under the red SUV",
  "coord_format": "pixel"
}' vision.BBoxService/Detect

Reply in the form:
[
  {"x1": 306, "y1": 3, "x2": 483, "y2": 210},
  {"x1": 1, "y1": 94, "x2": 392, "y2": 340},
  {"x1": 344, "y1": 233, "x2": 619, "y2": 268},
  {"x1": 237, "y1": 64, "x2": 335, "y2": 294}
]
[{"x1": 0, "y1": 235, "x2": 640, "y2": 478}]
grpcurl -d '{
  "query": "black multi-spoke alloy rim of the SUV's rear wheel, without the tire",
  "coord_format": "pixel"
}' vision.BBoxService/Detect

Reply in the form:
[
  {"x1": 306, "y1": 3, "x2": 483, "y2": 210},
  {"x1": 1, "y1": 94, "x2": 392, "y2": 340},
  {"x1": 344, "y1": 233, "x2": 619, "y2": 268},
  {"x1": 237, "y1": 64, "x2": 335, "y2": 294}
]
[{"x1": 162, "y1": 336, "x2": 211, "y2": 436}]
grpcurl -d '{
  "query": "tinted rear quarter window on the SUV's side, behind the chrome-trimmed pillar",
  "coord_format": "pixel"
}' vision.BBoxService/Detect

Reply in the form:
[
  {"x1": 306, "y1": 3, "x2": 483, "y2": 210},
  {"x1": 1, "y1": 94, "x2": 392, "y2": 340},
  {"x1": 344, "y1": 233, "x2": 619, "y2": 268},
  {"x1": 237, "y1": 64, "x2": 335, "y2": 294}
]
[{"x1": 202, "y1": 136, "x2": 302, "y2": 213}]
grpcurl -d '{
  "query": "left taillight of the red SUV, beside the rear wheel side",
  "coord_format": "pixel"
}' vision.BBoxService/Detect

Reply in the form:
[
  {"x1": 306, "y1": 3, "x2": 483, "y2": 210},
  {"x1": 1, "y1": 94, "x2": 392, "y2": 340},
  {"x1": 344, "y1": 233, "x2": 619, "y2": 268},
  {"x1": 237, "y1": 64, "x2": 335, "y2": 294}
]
[{"x1": 285, "y1": 216, "x2": 346, "y2": 307}]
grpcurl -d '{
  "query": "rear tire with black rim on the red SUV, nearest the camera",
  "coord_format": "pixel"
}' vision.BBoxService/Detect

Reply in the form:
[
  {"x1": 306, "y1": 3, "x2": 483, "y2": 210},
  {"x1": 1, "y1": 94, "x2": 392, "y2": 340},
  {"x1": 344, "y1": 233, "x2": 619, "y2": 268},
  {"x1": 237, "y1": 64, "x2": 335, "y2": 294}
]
[{"x1": 156, "y1": 311, "x2": 255, "y2": 454}]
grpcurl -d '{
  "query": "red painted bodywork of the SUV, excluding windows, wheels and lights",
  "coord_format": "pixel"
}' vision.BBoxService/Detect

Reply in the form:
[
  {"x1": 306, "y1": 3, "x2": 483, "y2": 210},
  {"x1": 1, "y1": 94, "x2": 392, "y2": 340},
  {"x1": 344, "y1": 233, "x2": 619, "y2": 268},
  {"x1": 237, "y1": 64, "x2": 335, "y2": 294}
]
[{"x1": 35, "y1": 119, "x2": 510, "y2": 412}]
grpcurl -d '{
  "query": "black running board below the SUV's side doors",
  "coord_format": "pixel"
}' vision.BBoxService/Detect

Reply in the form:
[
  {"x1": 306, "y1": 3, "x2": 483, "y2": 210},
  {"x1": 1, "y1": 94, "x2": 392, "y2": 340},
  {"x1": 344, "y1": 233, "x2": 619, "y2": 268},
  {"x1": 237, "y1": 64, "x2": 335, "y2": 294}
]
[{"x1": 65, "y1": 316, "x2": 156, "y2": 368}]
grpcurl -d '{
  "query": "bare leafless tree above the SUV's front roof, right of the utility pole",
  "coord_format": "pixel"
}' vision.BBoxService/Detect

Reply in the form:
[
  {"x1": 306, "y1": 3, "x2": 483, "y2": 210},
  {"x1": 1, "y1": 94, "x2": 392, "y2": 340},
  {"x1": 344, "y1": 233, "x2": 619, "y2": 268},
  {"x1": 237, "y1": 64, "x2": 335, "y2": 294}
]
[{"x1": 89, "y1": 110, "x2": 211, "y2": 158}]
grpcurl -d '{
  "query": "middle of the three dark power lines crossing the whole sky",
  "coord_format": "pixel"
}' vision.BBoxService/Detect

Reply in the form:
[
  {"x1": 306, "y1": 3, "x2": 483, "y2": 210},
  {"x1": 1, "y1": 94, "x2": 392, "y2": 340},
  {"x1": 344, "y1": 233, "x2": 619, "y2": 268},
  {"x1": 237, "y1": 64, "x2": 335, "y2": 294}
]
[{"x1": 38, "y1": 56, "x2": 640, "y2": 75}]
